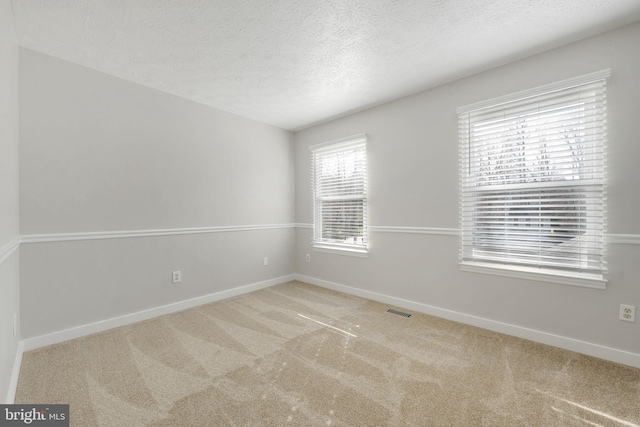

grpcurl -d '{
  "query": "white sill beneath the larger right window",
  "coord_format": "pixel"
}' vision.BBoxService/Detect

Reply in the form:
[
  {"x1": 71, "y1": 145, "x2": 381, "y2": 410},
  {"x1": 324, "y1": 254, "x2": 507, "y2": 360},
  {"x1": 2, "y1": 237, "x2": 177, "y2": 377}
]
[{"x1": 460, "y1": 262, "x2": 607, "y2": 289}]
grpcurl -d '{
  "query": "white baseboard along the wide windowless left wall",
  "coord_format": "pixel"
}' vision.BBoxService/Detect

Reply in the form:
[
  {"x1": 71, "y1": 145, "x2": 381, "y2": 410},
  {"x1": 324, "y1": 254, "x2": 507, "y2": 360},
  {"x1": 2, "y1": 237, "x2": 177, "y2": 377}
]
[{"x1": 23, "y1": 274, "x2": 295, "y2": 351}]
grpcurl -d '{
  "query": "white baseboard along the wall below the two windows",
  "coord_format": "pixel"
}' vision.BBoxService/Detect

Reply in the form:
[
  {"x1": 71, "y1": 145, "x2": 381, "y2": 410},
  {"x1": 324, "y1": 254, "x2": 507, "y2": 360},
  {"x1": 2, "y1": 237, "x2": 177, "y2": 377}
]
[{"x1": 294, "y1": 274, "x2": 640, "y2": 368}]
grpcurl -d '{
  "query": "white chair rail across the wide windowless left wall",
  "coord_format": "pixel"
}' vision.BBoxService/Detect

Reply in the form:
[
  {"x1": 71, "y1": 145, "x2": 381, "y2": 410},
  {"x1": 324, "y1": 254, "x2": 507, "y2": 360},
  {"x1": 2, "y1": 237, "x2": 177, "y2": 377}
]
[{"x1": 21, "y1": 224, "x2": 295, "y2": 244}]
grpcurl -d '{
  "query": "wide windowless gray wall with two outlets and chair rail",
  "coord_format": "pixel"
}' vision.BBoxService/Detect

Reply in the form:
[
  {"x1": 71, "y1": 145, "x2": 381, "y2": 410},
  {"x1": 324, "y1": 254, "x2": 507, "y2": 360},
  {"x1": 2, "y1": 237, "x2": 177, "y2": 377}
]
[{"x1": 20, "y1": 49, "x2": 295, "y2": 339}]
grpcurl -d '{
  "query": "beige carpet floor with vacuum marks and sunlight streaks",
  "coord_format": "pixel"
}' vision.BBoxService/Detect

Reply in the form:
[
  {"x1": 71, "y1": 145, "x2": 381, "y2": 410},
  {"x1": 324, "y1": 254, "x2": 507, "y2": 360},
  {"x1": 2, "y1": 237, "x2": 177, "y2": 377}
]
[{"x1": 16, "y1": 282, "x2": 640, "y2": 427}]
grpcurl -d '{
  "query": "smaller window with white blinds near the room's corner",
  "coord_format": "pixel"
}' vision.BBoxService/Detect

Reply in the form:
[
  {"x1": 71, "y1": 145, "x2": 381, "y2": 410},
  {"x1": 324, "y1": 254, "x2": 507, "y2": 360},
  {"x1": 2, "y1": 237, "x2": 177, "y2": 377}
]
[{"x1": 310, "y1": 134, "x2": 367, "y2": 256}]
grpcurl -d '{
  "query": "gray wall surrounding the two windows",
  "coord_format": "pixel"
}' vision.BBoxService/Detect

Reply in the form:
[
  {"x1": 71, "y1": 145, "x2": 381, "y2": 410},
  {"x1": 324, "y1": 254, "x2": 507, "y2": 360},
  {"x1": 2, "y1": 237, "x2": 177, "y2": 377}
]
[{"x1": 295, "y1": 23, "x2": 640, "y2": 354}]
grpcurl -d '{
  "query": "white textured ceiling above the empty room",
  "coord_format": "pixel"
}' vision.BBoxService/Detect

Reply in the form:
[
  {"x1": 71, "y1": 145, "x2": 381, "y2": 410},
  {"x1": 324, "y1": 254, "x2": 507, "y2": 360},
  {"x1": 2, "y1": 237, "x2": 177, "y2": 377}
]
[{"x1": 13, "y1": 0, "x2": 640, "y2": 130}]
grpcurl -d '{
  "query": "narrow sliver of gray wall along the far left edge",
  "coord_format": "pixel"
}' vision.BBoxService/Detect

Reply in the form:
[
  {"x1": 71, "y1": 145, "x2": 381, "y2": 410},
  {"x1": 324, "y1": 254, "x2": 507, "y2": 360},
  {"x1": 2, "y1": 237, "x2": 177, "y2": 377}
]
[{"x1": 0, "y1": 0, "x2": 20, "y2": 402}]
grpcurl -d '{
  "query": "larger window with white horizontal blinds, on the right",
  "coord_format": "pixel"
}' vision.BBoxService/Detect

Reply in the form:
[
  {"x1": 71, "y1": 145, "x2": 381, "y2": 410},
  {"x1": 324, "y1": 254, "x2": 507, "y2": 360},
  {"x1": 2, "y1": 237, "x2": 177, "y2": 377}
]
[{"x1": 458, "y1": 70, "x2": 609, "y2": 288}]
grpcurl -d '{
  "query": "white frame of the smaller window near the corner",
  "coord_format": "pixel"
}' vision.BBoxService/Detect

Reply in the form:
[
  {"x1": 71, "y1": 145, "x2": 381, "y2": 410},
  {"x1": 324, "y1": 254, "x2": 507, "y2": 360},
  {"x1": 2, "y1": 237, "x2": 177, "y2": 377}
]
[{"x1": 309, "y1": 133, "x2": 369, "y2": 257}]
